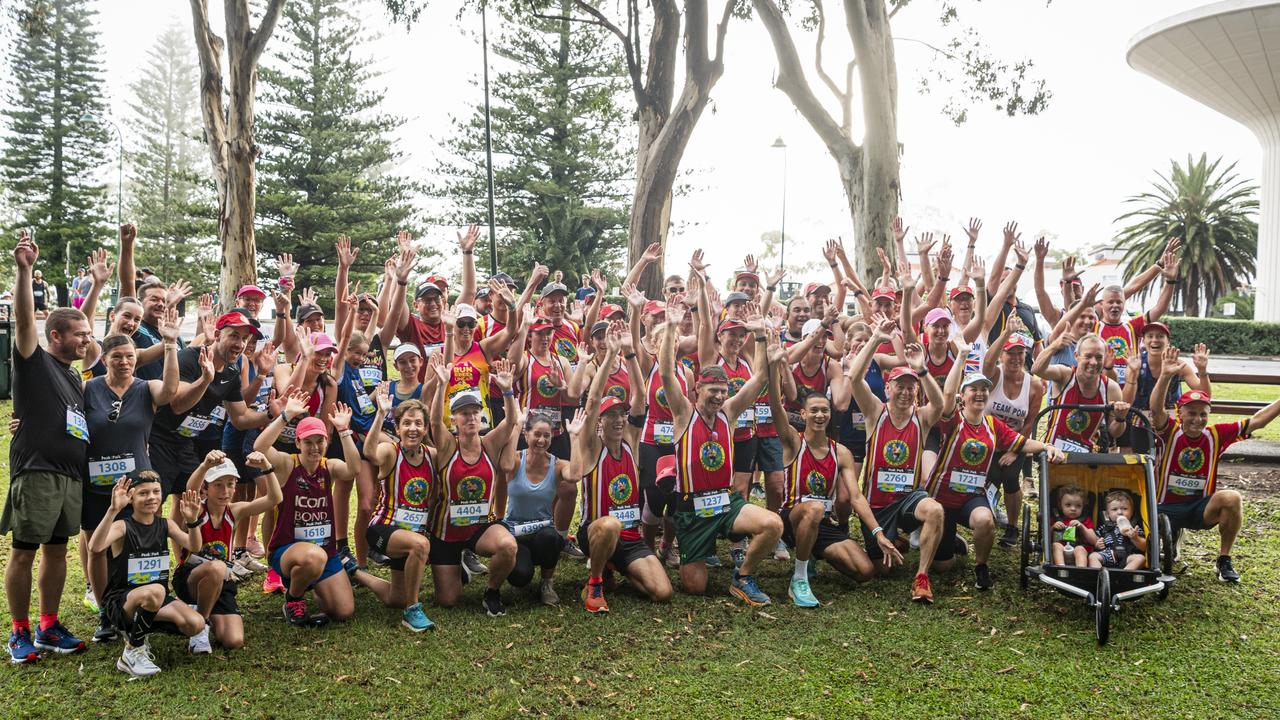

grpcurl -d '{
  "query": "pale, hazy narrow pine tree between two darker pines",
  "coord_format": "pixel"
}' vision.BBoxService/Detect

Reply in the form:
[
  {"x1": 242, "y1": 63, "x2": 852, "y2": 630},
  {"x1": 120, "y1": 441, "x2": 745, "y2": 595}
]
[{"x1": 127, "y1": 26, "x2": 220, "y2": 288}]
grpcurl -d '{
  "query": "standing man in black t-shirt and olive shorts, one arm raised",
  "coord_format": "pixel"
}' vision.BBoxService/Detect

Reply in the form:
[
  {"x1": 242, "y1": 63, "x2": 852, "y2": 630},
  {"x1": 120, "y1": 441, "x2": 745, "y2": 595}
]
[{"x1": 0, "y1": 233, "x2": 93, "y2": 664}]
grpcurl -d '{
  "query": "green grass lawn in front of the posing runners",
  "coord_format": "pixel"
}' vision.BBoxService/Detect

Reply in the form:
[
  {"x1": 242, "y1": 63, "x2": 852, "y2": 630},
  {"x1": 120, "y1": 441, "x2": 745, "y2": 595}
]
[{"x1": 0, "y1": 394, "x2": 1280, "y2": 719}]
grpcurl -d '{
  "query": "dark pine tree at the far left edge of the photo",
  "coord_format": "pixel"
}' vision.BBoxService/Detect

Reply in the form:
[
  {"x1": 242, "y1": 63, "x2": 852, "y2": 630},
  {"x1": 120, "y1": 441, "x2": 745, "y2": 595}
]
[{"x1": 0, "y1": 0, "x2": 111, "y2": 297}]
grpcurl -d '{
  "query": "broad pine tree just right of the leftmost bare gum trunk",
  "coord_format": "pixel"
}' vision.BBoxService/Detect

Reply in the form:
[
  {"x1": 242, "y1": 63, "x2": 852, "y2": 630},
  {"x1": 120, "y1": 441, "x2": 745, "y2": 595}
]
[{"x1": 256, "y1": 0, "x2": 417, "y2": 295}]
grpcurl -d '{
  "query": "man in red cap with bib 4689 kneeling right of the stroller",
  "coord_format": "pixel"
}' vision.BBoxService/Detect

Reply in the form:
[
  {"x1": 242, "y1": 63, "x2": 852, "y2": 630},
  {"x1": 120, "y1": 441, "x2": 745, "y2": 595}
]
[{"x1": 1151, "y1": 346, "x2": 1280, "y2": 583}]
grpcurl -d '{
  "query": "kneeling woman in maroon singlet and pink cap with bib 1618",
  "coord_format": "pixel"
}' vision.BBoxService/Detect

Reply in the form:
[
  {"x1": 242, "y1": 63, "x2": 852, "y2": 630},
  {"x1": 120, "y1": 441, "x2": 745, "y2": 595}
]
[{"x1": 253, "y1": 392, "x2": 387, "y2": 626}]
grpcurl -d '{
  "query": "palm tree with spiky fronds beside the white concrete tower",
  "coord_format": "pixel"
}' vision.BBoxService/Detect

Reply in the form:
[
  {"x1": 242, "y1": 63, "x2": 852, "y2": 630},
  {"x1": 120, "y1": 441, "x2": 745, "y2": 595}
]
[{"x1": 1115, "y1": 154, "x2": 1258, "y2": 315}]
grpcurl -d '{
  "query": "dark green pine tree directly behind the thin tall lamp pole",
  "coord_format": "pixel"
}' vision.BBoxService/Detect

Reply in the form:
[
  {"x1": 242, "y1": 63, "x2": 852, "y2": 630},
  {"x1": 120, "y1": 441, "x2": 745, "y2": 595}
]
[{"x1": 435, "y1": 3, "x2": 635, "y2": 278}]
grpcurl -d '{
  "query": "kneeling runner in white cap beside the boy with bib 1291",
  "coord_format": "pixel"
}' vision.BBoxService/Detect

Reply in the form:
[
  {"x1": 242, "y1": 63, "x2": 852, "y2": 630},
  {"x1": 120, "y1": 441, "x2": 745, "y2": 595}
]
[{"x1": 173, "y1": 450, "x2": 282, "y2": 653}]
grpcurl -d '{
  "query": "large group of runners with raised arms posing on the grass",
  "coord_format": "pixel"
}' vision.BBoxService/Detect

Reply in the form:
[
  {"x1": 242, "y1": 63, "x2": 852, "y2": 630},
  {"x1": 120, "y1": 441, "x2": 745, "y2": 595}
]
[{"x1": 0, "y1": 222, "x2": 1280, "y2": 676}]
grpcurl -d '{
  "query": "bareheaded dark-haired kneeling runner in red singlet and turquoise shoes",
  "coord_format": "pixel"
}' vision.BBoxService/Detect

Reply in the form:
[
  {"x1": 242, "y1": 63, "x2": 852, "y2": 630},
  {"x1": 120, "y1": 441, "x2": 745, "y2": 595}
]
[{"x1": 769, "y1": 336, "x2": 902, "y2": 607}]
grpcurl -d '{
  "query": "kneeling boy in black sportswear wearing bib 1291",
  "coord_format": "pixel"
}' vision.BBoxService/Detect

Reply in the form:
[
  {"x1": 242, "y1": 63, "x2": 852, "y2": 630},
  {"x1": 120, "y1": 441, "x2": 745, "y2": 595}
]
[{"x1": 90, "y1": 470, "x2": 205, "y2": 678}]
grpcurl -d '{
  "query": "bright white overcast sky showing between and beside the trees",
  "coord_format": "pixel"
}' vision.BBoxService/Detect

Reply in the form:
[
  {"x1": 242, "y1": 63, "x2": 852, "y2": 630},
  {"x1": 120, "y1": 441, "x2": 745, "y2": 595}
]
[{"x1": 99, "y1": 0, "x2": 1261, "y2": 285}]
